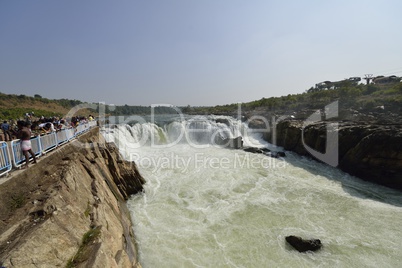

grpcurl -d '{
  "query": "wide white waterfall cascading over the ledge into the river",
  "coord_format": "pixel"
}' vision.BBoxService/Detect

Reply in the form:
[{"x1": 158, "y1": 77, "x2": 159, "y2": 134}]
[{"x1": 103, "y1": 116, "x2": 267, "y2": 150}]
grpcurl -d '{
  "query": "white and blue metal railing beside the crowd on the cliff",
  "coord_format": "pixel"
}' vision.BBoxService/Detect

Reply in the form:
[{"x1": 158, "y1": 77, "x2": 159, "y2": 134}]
[{"x1": 0, "y1": 121, "x2": 97, "y2": 176}]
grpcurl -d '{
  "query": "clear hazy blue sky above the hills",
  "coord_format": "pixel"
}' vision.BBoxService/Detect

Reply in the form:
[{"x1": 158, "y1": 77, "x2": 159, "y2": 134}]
[{"x1": 0, "y1": 0, "x2": 402, "y2": 106}]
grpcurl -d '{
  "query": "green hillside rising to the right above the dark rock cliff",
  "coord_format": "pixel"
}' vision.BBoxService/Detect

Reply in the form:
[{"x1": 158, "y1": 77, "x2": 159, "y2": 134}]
[{"x1": 183, "y1": 82, "x2": 402, "y2": 123}]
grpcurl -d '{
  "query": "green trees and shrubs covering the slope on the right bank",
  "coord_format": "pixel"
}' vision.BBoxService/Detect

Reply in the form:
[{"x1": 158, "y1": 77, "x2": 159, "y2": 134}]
[{"x1": 184, "y1": 82, "x2": 402, "y2": 115}]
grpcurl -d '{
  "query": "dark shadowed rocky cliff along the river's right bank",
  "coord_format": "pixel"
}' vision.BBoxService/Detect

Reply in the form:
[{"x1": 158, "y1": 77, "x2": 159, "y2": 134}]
[{"x1": 266, "y1": 120, "x2": 402, "y2": 189}]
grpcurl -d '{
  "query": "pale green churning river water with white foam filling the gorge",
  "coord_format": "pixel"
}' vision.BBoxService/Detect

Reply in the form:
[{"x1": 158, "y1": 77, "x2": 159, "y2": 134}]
[{"x1": 104, "y1": 116, "x2": 402, "y2": 268}]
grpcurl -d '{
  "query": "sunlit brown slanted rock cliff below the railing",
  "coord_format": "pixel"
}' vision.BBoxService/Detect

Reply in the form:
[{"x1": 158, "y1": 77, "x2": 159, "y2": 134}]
[{"x1": 0, "y1": 128, "x2": 144, "y2": 267}]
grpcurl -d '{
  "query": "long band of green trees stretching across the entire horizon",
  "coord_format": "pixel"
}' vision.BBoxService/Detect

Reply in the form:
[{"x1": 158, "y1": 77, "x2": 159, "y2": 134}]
[{"x1": 0, "y1": 82, "x2": 402, "y2": 119}]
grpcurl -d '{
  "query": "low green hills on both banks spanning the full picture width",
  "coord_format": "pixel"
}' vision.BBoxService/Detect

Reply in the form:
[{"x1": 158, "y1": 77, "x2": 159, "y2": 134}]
[{"x1": 0, "y1": 79, "x2": 402, "y2": 123}]
